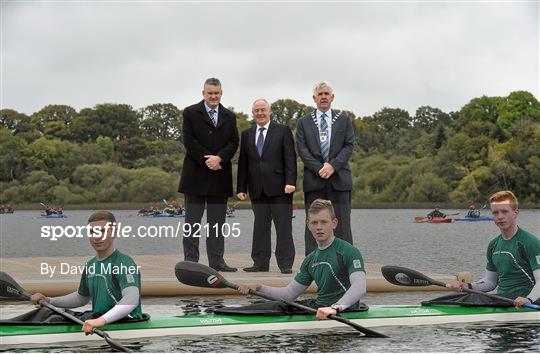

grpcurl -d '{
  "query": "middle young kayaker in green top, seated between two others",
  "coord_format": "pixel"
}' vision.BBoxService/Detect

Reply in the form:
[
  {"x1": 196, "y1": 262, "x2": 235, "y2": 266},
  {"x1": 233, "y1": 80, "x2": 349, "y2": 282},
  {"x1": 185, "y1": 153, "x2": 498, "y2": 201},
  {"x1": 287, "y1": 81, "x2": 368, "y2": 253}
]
[{"x1": 238, "y1": 199, "x2": 366, "y2": 320}]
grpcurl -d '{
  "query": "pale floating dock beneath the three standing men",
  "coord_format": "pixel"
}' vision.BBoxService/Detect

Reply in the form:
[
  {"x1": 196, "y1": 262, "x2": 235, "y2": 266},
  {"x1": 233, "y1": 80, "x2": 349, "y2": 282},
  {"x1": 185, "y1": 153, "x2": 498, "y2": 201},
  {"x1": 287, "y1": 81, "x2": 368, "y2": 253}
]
[{"x1": 0, "y1": 253, "x2": 470, "y2": 296}]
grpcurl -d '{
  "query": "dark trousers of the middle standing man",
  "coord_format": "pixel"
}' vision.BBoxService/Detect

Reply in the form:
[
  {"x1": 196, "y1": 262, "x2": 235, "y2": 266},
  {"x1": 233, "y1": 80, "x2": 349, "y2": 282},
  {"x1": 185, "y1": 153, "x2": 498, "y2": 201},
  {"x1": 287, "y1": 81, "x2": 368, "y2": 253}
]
[{"x1": 251, "y1": 193, "x2": 295, "y2": 269}]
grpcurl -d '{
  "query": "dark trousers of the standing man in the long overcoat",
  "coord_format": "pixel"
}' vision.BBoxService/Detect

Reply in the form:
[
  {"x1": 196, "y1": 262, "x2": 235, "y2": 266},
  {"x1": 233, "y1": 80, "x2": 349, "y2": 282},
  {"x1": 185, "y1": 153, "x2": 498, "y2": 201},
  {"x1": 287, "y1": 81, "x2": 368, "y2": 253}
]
[{"x1": 182, "y1": 194, "x2": 227, "y2": 267}]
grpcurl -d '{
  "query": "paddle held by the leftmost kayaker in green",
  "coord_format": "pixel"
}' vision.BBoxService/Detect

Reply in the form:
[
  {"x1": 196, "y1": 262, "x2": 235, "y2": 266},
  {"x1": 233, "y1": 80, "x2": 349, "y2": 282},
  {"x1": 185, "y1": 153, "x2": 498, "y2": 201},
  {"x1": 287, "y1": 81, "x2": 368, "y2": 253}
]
[{"x1": 0, "y1": 271, "x2": 132, "y2": 353}]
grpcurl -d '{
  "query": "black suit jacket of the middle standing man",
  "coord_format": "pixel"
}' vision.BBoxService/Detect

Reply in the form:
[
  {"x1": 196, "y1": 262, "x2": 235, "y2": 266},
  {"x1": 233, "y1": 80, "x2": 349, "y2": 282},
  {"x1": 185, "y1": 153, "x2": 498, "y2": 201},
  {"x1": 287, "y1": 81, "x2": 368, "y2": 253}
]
[{"x1": 236, "y1": 121, "x2": 297, "y2": 199}]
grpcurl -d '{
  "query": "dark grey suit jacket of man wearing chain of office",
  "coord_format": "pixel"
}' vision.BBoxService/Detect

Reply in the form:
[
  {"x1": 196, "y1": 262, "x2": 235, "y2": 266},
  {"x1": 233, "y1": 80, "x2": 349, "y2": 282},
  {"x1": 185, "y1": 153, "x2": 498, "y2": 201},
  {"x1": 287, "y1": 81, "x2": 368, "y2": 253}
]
[{"x1": 296, "y1": 111, "x2": 355, "y2": 192}]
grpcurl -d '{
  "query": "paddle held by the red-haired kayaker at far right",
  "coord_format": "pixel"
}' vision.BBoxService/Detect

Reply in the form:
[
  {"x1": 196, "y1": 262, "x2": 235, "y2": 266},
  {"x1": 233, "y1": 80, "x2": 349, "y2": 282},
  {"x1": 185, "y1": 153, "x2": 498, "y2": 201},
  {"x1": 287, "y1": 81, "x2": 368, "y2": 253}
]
[{"x1": 381, "y1": 266, "x2": 540, "y2": 310}]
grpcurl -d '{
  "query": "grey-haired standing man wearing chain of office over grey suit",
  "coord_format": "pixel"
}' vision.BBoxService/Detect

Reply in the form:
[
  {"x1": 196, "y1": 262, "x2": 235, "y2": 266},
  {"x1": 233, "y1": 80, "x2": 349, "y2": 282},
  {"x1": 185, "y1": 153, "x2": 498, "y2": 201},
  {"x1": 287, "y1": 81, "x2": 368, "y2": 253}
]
[{"x1": 296, "y1": 82, "x2": 355, "y2": 255}]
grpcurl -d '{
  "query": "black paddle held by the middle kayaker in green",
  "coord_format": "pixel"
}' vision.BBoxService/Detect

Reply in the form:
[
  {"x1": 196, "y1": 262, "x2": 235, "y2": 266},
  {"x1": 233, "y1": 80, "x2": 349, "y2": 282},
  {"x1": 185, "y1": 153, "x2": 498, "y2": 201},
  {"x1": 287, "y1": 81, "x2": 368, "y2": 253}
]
[{"x1": 174, "y1": 261, "x2": 388, "y2": 338}]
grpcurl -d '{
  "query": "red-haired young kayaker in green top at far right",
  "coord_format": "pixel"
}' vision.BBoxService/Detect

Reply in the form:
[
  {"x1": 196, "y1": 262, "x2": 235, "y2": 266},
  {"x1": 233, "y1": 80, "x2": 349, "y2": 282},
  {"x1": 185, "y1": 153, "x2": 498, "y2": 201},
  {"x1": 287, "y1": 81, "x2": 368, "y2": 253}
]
[{"x1": 449, "y1": 191, "x2": 540, "y2": 307}]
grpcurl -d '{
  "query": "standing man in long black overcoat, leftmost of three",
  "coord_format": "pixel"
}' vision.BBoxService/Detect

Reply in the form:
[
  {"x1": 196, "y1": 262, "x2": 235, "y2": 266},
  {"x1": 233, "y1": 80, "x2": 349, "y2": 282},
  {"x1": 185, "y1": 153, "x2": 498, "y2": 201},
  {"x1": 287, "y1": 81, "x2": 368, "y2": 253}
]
[{"x1": 178, "y1": 78, "x2": 238, "y2": 272}]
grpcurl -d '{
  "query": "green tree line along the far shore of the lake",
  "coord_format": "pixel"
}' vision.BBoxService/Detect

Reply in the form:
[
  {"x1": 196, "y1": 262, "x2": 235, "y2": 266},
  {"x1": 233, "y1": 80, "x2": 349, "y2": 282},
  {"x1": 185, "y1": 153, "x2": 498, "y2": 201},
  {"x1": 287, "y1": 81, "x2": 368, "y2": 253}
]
[{"x1": 0, "y1": 91, "x2": 540, "y2": 204}]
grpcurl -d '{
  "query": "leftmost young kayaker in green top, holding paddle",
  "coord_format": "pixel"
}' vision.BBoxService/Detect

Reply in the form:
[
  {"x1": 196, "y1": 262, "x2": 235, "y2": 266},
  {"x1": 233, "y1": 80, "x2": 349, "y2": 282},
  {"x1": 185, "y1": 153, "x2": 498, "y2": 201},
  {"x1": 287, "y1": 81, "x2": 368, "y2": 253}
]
[{"x1": 31, "y1": 211, "x2": 142, "y2": 334}]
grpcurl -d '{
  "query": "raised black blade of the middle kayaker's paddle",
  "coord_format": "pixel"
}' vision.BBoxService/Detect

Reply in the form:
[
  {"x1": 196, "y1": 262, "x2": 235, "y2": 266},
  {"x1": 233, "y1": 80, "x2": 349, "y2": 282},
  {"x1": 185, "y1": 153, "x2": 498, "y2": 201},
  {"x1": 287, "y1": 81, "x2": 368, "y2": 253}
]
[{"x1": 174, "y1": 261, "x2": 228, "y2": 288}]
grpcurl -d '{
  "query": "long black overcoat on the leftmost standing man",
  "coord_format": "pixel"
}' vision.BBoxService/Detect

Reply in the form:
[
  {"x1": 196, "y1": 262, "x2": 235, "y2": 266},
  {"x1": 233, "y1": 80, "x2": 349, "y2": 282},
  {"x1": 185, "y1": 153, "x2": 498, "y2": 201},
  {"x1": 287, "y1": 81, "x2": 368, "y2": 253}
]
[{"x1": 178, "y1": 100, "x2": 238, "y2": 197}]
